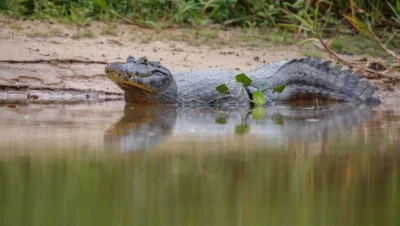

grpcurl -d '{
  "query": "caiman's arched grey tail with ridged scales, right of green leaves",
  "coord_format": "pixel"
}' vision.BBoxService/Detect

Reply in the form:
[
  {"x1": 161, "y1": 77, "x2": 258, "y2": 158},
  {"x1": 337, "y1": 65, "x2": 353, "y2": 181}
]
[{"x1": 248, "y1": 57, "x2": 380, "y2": 103}]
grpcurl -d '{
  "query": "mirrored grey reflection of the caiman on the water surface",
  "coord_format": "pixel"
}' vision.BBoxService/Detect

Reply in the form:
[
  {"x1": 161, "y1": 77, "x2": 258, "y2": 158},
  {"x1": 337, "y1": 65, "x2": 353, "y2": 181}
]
[{"x1": 104, "y1": 103, "x2": 388, "y2": 151}]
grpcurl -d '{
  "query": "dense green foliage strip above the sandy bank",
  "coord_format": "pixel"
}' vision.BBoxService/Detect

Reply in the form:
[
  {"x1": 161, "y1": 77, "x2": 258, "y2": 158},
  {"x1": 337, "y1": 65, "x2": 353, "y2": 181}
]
[{"x1": 0, "y1": 0, "x2": 400, "y2": 30}]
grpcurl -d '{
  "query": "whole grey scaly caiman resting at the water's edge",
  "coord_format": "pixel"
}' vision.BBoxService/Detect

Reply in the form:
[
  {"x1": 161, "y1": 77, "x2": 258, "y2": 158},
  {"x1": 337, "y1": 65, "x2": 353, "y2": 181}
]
[{"x1": 105, "y1": 56, "x2": 380, "y2": 106}]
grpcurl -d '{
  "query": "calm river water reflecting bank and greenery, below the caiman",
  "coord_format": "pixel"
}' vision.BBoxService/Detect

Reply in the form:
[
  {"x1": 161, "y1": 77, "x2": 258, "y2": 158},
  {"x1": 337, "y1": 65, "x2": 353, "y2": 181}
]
[{"x1": 0, "y1": 102, "x2": 400, "y2": 225}]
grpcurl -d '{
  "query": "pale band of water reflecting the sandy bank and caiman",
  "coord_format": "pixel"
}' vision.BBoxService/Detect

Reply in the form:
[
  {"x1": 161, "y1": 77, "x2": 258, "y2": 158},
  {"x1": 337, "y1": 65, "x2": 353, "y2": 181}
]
[{"x1": 0, "y1": 102, "x2": 400, "y2": 153}]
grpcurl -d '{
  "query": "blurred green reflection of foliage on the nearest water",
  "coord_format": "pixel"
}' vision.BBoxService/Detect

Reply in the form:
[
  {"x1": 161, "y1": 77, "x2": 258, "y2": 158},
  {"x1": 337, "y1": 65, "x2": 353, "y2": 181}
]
[{"x1": 0, "y1": 152, "x2": 400, "y2": 226}]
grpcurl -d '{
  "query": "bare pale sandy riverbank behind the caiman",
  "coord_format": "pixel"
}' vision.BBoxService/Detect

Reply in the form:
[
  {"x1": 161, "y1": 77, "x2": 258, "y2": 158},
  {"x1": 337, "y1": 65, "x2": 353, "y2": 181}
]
[{"x1": 0, "y1": 20, "x2": 400, "y2": 104}]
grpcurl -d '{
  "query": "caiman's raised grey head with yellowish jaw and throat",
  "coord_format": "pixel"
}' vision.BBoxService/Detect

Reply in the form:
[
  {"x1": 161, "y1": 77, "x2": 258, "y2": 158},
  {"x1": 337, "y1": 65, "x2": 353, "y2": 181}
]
[{"x1": 105, "y1": 56, "x2": 177, "y2": 104}]
